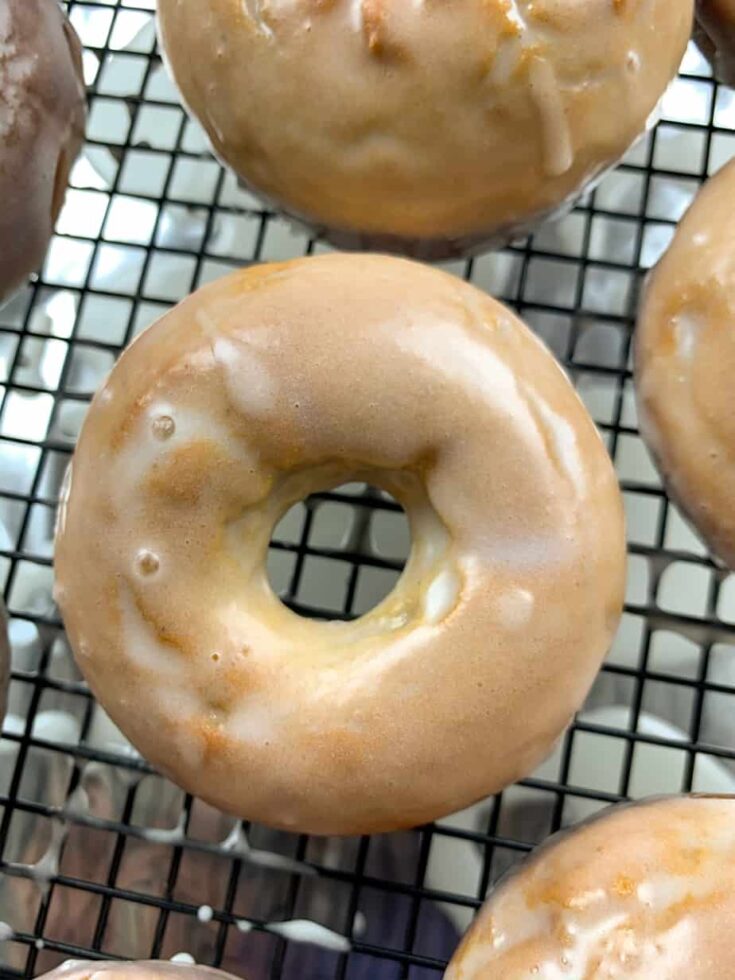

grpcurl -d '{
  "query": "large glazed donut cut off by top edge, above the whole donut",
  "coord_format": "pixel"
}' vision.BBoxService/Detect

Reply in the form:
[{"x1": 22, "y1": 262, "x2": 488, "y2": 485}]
[{"x1": 158, "y1": 0, "x2": 694, "y2": 258}]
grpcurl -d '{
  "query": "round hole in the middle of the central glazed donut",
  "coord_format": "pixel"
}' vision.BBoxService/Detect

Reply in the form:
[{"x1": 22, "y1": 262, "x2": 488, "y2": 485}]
[{"x1": 268, "y1": 483, "x2": 411, "y2": 620}]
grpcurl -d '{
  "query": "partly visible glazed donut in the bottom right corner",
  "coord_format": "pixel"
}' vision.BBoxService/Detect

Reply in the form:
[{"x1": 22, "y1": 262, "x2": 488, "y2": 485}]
[{"x1": 444, "y1": 796, "x2": 735, "y2": 980}]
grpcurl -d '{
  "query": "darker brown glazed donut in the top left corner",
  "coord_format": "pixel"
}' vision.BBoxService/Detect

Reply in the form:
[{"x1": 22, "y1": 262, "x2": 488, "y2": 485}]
[{"x1": 0, "y1": 0, "x2": 85, "y2": 300}]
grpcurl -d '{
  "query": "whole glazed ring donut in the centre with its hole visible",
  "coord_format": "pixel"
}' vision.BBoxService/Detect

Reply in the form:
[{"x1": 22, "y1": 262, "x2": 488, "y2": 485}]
[{"x1": 55, "y1": 254, "x2": 625, "y2": 834}]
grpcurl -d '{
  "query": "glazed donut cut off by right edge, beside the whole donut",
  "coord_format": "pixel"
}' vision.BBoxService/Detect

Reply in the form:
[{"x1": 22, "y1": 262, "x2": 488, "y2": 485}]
[{"x1": 635, "y1": 157, "x2": 735, "y2": 568}]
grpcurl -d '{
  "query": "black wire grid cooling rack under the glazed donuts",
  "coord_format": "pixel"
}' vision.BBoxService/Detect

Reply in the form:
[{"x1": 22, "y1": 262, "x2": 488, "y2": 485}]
[{"x1": 0, "y1": 0, "x2": 735, "y2": 980}]
